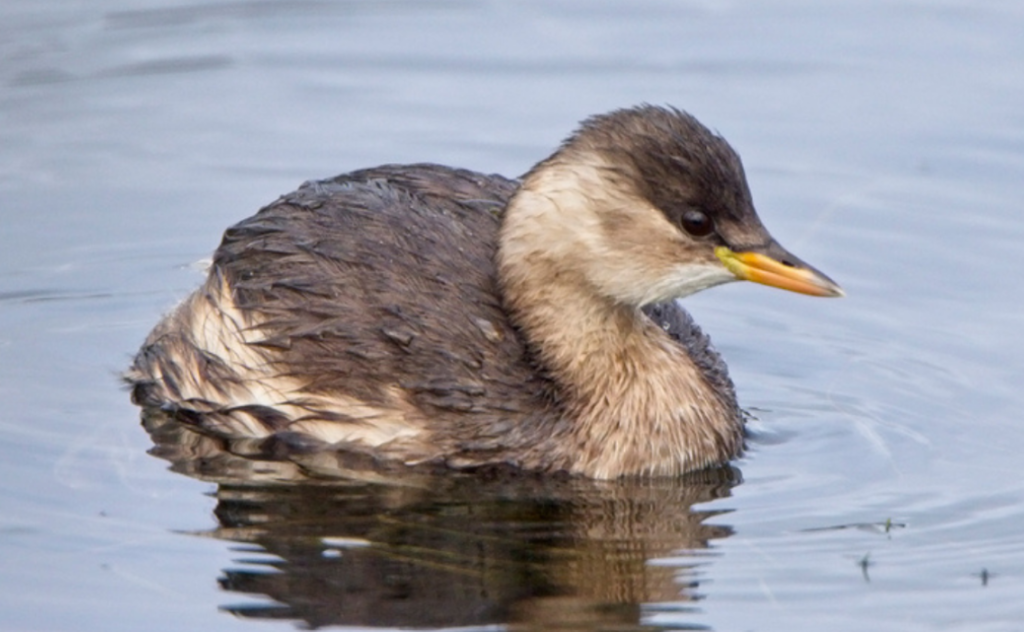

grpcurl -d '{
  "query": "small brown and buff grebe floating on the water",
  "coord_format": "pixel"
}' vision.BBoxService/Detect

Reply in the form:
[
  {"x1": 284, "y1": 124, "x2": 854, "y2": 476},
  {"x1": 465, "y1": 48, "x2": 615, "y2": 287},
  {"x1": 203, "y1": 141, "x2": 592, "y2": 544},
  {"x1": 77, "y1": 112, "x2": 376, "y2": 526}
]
[{"x1": 127, "y1": 106, "x2": 842, "y2": 478}]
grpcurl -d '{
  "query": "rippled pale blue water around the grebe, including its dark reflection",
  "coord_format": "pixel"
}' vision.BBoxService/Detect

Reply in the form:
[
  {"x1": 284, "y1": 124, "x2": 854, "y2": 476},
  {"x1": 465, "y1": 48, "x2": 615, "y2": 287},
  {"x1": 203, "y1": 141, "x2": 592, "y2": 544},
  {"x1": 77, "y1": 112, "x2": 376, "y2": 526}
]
[{"x1": 0, "y1": 0, "x2": 1024, "y2": 631}]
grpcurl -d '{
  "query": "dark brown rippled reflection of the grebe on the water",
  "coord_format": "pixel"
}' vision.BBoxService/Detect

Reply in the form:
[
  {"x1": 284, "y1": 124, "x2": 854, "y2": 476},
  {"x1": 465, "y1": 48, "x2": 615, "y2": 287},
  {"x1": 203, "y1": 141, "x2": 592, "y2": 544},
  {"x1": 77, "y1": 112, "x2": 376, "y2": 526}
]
[{"x1": 143, "y1": 413, "x2": 738, "y2": 630}]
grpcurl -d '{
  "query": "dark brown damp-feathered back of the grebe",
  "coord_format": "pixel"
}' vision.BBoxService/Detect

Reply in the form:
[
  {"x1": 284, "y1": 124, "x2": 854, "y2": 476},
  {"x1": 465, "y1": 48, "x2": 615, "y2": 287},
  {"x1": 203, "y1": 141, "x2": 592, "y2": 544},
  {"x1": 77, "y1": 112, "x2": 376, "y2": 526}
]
[{"x1": 220, "y1": 165, "x2": 528, "y2": 413}]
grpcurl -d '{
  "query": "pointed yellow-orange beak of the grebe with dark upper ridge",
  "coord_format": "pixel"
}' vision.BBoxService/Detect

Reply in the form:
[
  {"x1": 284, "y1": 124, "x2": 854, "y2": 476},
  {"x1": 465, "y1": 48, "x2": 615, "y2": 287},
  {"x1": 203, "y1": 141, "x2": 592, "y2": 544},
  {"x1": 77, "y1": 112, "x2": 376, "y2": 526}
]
[{"x1": 715, "y1": 242, "x2": 845, "y2": 296}]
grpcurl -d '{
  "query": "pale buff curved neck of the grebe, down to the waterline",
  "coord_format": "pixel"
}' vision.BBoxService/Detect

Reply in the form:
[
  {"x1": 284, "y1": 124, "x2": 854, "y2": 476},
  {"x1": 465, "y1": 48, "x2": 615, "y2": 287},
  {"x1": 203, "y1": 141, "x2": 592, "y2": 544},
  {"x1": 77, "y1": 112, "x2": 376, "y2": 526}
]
[{"x1": 498, "y1": 170, "x2": 741, "y2": 478}]
